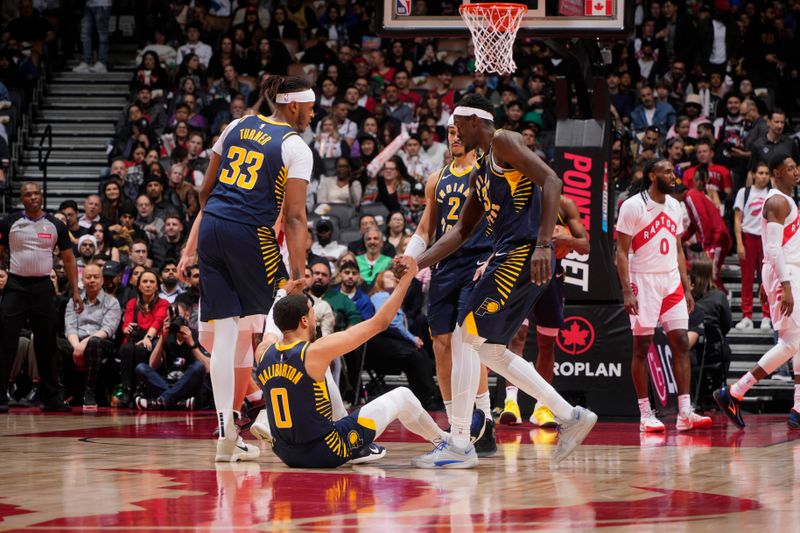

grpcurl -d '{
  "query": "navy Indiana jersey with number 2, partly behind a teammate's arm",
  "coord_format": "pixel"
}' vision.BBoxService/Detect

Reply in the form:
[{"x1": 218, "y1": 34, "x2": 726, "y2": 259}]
[{"x1": 436, "y1": 163, "x2": 492, "y2": 255}]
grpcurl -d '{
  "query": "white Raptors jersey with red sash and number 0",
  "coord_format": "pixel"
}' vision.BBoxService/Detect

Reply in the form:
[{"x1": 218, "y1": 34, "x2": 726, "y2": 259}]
[{"x1": 617, "y1": 192, "x2": 683, "y2": 272}]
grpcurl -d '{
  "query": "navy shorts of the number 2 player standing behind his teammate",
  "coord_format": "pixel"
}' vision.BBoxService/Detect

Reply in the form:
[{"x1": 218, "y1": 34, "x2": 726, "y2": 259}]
[{"x1": 428, "y1": 252, "x2": 490, "y2": 337}]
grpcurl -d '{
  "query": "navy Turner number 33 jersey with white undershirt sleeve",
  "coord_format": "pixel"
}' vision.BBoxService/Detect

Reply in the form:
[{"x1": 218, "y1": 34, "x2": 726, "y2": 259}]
[{"x1": 204, "y1": 115, "x2": 314, "y2": 227}]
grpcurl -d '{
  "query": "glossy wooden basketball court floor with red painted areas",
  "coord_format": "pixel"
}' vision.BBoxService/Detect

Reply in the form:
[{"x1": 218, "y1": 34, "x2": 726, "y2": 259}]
[{"x1": 0, "y1": 409, "x2": 800, "y2": 533}]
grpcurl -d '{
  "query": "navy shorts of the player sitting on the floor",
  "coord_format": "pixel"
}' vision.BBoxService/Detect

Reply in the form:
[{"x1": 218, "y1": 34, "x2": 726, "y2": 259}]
[{"x1": 272, "y1": 410, "x2": 375, "y2": 468}]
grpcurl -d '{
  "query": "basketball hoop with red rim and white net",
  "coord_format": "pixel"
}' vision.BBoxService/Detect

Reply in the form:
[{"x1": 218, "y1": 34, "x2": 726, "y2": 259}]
[{"x1": 458, "y1": 2, "x2": 528, "y2": 74}]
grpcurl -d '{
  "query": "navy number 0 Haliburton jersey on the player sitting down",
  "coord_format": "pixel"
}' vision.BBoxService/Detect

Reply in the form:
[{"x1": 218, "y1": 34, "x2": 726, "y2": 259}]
[{"x1": 257, "y1": 341, "x2": 349, "y2": 460}]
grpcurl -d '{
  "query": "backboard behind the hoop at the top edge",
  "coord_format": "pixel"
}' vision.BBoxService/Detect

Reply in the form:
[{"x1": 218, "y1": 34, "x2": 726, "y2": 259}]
[{"x1": 377, "y1": 0, "x2": 635, "y2": 39}]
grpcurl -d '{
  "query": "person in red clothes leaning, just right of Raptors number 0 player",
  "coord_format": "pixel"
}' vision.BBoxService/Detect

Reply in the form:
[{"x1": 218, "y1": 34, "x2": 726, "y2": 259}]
[{"x1": 675, "y1": 179, "x2": 731, "y2": 294}]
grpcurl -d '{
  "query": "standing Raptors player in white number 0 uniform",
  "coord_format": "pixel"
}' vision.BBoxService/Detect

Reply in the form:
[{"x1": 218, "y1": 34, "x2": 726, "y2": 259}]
[{"x1": 617, "y1": 158, "x2": 711, "y2": 432}]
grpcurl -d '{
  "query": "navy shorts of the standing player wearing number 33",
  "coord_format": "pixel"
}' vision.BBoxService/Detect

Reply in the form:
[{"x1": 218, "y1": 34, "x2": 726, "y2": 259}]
[{"x1": 197, "y1": 214, "x2": 286, "y2": 321}]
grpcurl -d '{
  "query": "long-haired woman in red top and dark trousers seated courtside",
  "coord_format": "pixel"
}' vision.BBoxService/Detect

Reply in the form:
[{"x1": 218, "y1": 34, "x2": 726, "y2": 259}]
[{"x1": 118, "y1": 270, "x2": 169, "y2": 407}]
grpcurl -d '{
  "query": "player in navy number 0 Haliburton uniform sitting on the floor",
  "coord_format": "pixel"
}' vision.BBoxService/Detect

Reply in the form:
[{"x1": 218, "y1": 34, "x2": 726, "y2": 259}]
[{"x1": 257, "y1": 257, "x2": 484, "y2": 468}]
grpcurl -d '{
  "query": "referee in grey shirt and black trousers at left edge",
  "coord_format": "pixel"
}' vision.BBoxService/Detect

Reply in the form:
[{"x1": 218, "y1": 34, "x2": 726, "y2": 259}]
[{"x1": 0, "y1": 182, "x2": 83, "y2": 413}]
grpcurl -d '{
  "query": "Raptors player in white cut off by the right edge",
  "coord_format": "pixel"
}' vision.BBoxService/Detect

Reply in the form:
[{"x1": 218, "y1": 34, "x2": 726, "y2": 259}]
[{"x1": 714, "y1": 153, "x2": 800, "y2": 429}]
